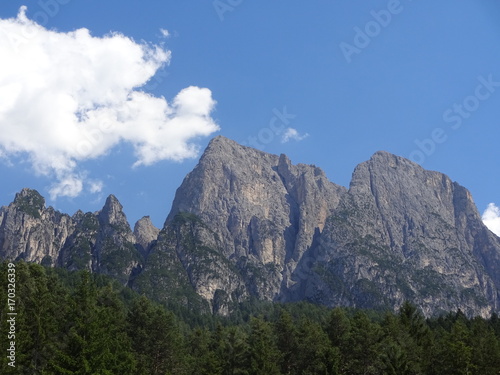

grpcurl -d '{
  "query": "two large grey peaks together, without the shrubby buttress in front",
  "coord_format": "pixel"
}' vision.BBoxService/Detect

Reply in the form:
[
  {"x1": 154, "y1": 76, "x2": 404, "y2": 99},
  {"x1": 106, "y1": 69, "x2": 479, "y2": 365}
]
[{"x1": 166, "y1": 137, "x2": 500, "y2": 316}]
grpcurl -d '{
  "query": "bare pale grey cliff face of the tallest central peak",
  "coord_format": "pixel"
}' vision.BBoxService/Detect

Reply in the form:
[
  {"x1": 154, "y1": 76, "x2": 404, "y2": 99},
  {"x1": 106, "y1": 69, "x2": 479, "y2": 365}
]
[{"x1": 166, "y1": 136, "x2": 345, "y2": 300}]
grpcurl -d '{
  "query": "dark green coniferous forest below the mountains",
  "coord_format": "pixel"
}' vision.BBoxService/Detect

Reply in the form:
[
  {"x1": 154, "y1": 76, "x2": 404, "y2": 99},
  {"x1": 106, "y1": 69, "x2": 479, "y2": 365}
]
[{"x1": 0, "y1": 262, "x2": 500, "y2": 375}]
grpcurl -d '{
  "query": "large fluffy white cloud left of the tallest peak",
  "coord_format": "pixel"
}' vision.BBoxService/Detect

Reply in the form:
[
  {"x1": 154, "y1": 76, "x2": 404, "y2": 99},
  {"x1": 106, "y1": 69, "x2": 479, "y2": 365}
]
[{"x1": 0, "y1": 7, "x2": 219, "y2": 198}]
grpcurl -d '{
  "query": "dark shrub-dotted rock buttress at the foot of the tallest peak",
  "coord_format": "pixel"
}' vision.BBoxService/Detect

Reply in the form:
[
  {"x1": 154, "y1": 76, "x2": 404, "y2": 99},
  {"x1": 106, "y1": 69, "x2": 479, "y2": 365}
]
[{"x1": 133, "y1": 213, "x2": 248, "y2": 315}]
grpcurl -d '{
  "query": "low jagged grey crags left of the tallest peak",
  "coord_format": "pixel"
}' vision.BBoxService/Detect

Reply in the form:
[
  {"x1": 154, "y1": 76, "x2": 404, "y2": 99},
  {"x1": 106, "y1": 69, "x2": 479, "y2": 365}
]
[{"x1": 0, "y1": 189, "x2": 142, "y2": 284}]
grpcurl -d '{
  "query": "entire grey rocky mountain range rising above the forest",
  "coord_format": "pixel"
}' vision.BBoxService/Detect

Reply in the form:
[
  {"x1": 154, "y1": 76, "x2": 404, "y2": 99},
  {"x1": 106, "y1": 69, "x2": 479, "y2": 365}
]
[{"x1": 0, "y1": 136, "x2": 500, "y2": 316}]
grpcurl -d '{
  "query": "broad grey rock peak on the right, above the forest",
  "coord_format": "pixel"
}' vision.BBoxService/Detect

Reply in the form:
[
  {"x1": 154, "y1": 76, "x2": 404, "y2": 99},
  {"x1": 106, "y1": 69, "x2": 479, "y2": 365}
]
[{"x1": 294, "y1": 152, "x2": 500, "y2": 315}]
